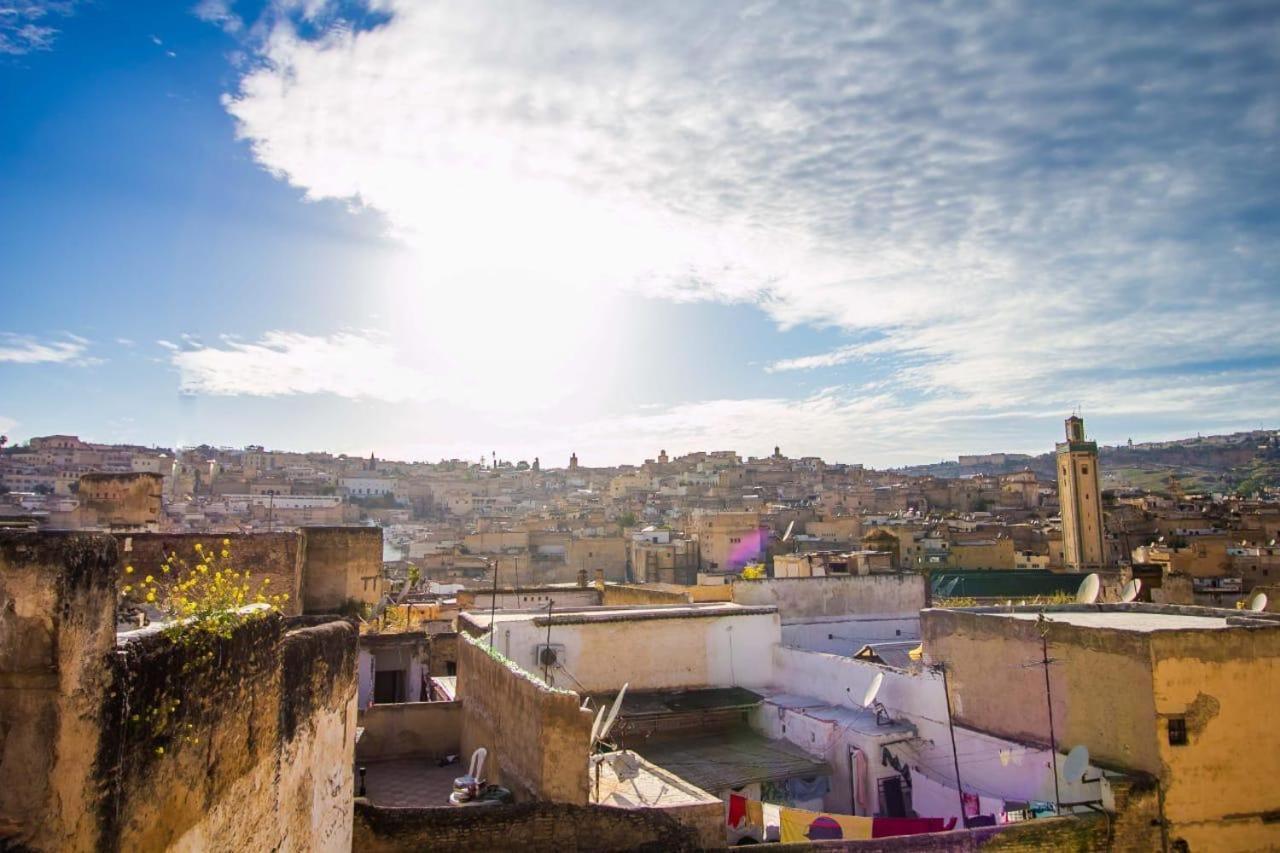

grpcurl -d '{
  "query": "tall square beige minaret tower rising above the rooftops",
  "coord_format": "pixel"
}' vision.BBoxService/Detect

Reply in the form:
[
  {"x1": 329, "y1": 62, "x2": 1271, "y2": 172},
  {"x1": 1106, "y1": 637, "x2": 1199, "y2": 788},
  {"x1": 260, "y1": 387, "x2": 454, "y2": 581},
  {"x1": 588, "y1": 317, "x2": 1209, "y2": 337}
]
[{"x1": 1057, "y1": 415, "x2": 1106, "y2": 571}]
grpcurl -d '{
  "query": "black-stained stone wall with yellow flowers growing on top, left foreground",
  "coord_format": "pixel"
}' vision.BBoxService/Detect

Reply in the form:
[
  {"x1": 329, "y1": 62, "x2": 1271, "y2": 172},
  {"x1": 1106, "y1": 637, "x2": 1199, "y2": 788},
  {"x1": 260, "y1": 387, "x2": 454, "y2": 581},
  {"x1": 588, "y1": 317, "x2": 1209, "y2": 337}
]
[{"x1": 0, "y1": 532, "x2": 356, "y2": 850}]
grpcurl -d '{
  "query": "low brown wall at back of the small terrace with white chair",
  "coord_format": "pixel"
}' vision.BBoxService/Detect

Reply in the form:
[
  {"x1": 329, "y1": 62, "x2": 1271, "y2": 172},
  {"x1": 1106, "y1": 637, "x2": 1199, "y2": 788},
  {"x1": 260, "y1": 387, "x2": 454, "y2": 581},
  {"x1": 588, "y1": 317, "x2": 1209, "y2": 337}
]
[{"x1": 356, "y1": 702, "x2": 462, "y2": 761}]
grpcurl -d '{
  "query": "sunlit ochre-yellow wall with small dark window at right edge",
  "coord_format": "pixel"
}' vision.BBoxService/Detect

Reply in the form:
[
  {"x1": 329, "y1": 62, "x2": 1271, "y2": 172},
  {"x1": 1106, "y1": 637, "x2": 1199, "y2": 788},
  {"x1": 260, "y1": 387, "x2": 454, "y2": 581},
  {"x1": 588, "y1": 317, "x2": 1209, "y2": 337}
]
[{"x1": 1151, "y1": 628, "x2": 1280, "y2": 850}]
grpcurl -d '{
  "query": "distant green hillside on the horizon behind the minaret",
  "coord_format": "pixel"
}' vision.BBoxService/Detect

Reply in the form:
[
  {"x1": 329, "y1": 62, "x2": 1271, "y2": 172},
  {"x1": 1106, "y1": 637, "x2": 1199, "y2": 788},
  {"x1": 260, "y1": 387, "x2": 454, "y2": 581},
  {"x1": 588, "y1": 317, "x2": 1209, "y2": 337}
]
[{"x1": 893, "y1": 430, "x2": 1280, "y2": 494}]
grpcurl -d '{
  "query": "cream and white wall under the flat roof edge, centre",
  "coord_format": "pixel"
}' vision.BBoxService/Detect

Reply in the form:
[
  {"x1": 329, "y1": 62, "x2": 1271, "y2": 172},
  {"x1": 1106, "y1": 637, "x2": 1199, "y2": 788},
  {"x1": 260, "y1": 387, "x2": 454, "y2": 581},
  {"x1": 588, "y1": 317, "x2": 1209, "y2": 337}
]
[{"x1": 497, "y1": 611, "x2": 781, "y2": 693}]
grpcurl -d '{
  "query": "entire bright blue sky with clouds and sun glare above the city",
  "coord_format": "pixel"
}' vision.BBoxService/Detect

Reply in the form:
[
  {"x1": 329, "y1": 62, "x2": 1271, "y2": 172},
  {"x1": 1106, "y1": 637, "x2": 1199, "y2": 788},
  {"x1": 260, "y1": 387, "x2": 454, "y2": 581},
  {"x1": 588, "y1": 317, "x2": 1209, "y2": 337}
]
[{"x1": 0, "y1": 0, "x2": 1280, "y2": 466}]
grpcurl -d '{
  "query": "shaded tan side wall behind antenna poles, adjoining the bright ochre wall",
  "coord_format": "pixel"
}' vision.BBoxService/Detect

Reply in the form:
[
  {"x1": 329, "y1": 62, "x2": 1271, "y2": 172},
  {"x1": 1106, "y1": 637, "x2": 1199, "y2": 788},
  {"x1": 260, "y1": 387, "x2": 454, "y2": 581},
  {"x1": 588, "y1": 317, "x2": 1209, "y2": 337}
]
[{"x1": 920, "y1": 610, "x2": 1160, "y2": 775}]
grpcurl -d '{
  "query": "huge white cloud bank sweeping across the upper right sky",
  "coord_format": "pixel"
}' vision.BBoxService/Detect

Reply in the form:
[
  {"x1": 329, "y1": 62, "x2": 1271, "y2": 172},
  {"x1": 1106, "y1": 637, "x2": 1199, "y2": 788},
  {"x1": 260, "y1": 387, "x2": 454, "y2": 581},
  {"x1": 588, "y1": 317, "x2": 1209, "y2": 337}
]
[{"x1": 227, "y1": 0, "x2": 1280, "y2": 458}]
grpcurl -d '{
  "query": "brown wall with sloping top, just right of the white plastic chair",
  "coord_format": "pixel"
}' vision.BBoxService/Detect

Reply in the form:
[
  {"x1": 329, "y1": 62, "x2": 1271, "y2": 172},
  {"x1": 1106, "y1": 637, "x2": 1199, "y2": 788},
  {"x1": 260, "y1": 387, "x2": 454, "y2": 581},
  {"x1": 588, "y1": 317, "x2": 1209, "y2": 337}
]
[{"x1": 458, "y1": 635, "x2": 593, "y2": 804}]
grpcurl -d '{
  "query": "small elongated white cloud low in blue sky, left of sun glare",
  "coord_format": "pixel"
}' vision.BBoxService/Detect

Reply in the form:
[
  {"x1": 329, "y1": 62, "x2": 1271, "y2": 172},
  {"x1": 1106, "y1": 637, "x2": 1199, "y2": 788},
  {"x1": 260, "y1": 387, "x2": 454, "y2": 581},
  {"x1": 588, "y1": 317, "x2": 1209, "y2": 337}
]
[{"x1": 161, "y1": 332, "x2": 426, "y2": 402}]
